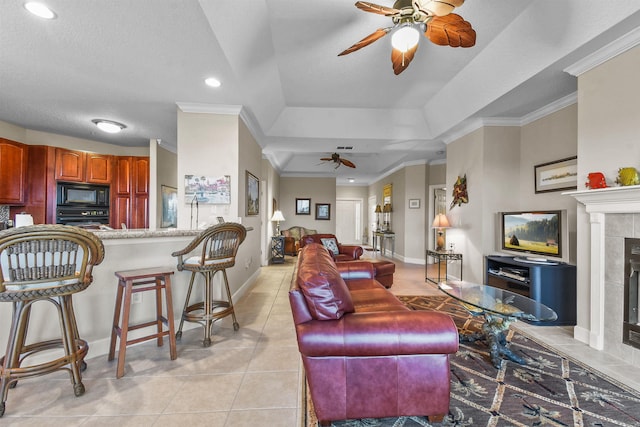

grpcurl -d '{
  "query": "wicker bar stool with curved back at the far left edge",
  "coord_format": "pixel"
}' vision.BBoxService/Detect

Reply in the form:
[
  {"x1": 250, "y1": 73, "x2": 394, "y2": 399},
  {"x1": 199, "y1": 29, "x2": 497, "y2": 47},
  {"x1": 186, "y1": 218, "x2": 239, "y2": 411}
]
[{"x1": 0, "y1": 225, "x2": 104, "y2": 416}]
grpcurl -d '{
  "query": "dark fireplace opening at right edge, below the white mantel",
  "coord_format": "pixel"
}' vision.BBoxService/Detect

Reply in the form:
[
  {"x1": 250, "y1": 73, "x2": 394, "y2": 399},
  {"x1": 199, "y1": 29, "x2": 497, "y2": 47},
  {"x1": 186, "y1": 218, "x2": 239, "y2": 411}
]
[{"x1": 622, "y1": 238, "x2": 640, "y2": 348}]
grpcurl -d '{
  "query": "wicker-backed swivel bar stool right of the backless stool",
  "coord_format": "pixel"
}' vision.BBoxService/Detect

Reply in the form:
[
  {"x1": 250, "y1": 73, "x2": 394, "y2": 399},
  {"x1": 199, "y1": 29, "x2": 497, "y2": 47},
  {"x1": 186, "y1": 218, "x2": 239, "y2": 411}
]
[{"x1": 171, "y1": 222, "x2": 247, "y2": 347}]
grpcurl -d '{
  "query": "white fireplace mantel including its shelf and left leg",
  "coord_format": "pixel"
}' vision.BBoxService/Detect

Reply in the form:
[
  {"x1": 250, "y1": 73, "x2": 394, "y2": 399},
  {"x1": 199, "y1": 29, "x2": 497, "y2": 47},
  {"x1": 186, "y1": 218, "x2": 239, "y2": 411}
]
[{"x1": 562, "y1": 185, "x2": 640, "y2": 350}]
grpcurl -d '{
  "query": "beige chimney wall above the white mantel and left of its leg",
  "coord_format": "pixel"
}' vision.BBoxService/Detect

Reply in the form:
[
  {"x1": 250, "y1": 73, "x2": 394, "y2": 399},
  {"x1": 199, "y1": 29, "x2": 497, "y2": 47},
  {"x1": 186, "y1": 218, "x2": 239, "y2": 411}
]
[{"x1": 576, "y1": 47, "x2": 640, "y2": 341}]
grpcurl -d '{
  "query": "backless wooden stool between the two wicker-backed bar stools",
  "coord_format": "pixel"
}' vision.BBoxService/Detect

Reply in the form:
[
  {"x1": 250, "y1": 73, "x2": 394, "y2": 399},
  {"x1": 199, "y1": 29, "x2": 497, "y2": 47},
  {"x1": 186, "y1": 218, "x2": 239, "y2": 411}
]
[{"x1": 108, "y1": 267, "x2": 177, "y2": 378}]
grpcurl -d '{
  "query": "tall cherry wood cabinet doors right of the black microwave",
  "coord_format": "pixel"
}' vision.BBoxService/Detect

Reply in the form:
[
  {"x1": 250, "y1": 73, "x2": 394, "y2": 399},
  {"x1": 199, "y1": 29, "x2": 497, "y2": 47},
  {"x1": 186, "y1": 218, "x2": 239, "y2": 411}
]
[{"x1": 111, "y1": 156, "x2": 149, "y2": 228}]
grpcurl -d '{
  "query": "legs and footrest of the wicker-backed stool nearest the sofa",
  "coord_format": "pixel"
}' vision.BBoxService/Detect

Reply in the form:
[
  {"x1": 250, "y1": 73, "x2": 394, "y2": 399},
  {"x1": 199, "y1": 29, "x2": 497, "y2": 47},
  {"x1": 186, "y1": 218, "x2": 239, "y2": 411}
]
[{"x1": 176, "y1": 269, "x2": 240, "y2": 347}]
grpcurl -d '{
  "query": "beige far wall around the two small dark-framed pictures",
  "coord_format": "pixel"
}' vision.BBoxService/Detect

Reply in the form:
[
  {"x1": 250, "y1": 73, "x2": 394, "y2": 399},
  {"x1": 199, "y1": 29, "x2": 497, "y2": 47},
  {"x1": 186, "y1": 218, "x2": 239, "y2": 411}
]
[{"x1": 279, "y1": 177, "x2": 336, "y2": 234}]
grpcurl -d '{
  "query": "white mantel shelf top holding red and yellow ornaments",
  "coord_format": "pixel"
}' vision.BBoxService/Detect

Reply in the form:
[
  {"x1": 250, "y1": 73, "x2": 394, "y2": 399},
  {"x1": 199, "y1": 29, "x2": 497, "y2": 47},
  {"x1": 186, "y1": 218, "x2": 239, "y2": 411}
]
[{"x1": 562, "y1": 185, "x2": 640, "y2": 213}]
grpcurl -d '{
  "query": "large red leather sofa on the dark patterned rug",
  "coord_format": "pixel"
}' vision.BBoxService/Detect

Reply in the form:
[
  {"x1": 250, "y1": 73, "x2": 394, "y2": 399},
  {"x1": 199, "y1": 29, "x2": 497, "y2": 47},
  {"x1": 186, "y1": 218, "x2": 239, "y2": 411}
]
[{"x1": 289, "y1": 243, "x2": 458, "y2": 425}]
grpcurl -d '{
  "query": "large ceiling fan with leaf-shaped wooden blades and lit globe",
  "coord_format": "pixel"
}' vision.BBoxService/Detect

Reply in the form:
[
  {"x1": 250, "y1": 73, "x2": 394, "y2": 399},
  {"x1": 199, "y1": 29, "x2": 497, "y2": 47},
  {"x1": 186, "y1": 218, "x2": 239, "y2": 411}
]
[{"x1": 338, "y1": 0, "x2": 476, "y2": 75}]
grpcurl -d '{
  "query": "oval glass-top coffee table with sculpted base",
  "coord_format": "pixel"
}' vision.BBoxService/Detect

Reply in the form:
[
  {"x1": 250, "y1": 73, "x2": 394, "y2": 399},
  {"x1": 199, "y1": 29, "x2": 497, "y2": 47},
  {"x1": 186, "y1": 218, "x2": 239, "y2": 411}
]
[{"x1": 438, "y1": 280, "x2": 558, "y2": 368}]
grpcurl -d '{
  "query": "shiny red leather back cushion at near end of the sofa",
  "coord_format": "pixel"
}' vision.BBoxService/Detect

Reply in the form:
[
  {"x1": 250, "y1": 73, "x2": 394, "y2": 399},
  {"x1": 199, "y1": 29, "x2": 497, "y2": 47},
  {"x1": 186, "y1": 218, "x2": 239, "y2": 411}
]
[{"x1": 297, "y1": 244, "x2": 354, "y2": 320}]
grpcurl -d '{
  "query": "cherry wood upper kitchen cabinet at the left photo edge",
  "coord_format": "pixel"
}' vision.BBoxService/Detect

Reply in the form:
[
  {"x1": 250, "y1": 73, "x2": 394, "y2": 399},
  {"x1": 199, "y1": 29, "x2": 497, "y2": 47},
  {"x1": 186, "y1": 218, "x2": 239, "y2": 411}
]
[{"x1": 0, "y1": 138, "x2": 28, "y2": 205}]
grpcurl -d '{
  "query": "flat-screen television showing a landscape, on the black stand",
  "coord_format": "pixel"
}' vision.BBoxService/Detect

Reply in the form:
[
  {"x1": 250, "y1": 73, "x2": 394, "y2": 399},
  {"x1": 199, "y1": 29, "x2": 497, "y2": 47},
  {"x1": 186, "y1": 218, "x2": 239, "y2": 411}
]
[{"x1": 498, "y1": 210, "x2": 569, "y2": 263}]
